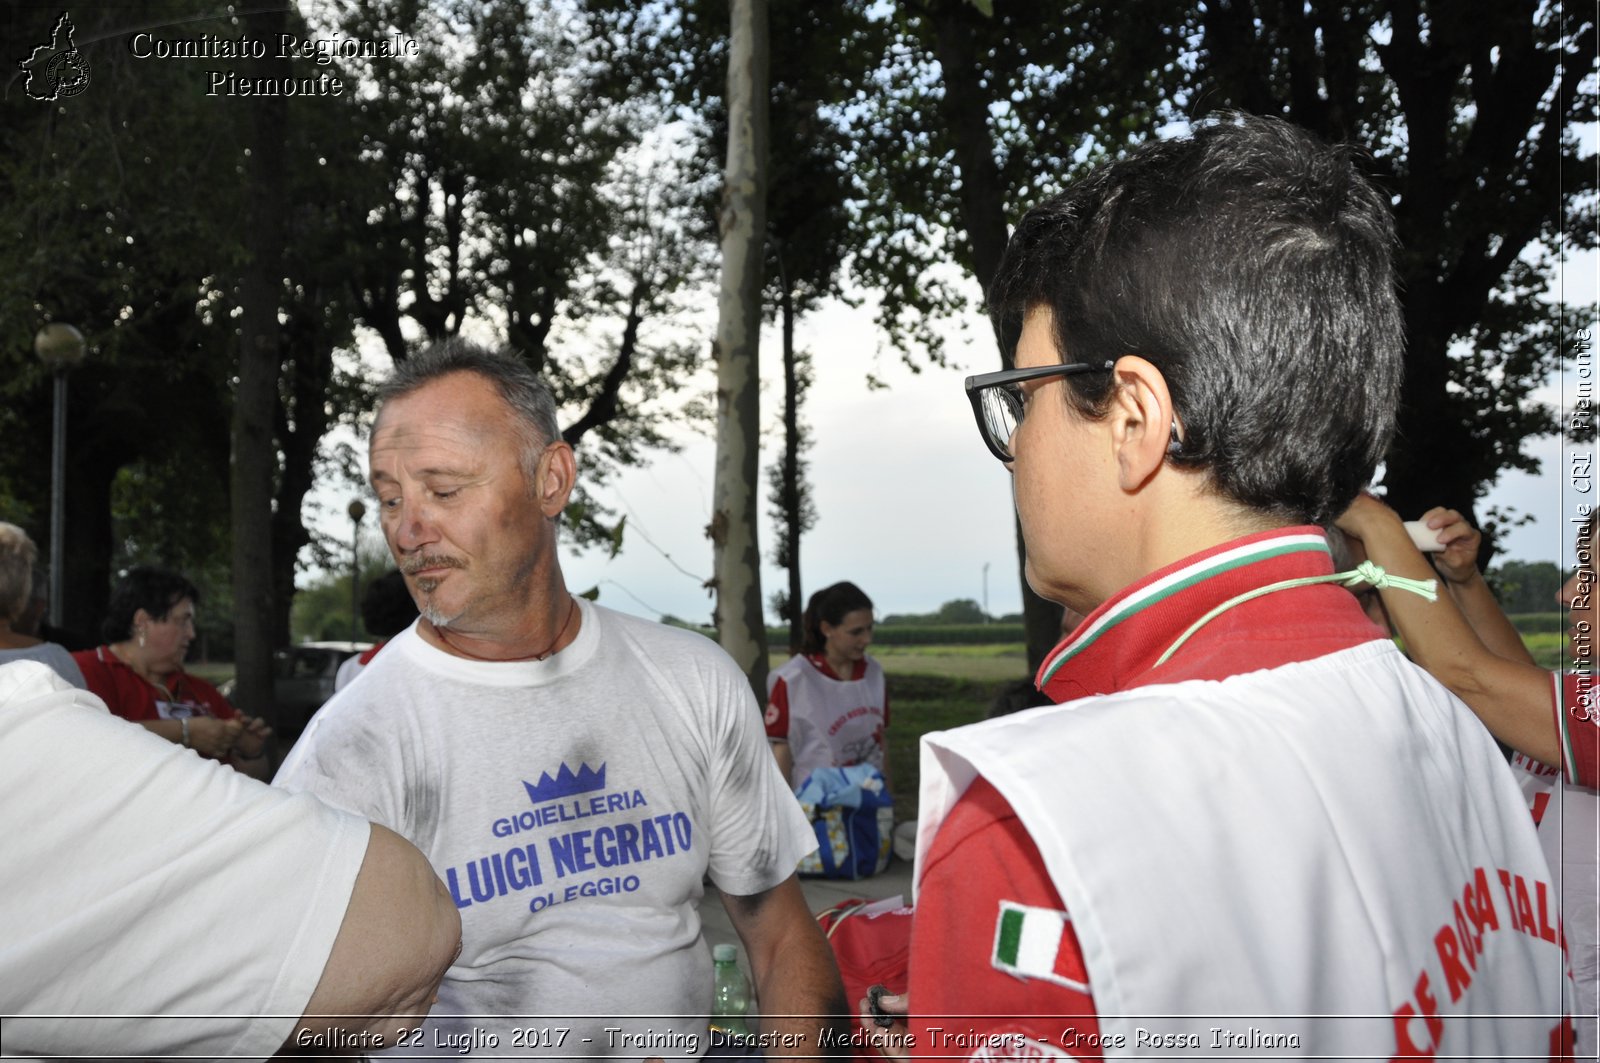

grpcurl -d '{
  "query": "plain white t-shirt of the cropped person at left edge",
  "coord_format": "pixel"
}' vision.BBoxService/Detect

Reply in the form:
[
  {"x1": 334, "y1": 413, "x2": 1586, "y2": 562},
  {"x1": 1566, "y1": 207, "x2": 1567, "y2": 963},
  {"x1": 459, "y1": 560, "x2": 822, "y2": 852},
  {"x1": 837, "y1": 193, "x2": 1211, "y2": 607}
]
[{"x1": 0, "y1": 661, "x2": 371, "y2": 1060}]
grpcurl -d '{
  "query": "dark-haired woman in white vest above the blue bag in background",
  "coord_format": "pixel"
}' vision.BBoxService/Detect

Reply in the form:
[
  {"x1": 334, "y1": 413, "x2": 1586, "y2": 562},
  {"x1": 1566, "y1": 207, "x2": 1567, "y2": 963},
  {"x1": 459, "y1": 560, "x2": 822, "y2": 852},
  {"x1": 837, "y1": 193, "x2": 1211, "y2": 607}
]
[{"x1": 766, "y1": 583, "x2": 890, "y2": 789}]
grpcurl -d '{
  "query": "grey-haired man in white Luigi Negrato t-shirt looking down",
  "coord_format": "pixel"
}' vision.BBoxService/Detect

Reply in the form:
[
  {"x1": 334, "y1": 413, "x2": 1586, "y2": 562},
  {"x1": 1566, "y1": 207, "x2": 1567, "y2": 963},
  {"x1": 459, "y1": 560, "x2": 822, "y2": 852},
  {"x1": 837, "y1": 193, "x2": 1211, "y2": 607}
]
[{"x1": 277, "y1": 343, "x2": 843, "y2": 1058}]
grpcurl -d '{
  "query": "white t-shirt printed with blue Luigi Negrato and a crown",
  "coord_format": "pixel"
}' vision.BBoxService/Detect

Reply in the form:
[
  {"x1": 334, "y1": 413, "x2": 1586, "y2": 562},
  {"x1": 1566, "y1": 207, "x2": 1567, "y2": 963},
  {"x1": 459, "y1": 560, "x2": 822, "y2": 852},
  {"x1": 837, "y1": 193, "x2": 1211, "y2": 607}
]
[{"x1": 277, "y1": 600, "x2": 816, "y2": 1058}]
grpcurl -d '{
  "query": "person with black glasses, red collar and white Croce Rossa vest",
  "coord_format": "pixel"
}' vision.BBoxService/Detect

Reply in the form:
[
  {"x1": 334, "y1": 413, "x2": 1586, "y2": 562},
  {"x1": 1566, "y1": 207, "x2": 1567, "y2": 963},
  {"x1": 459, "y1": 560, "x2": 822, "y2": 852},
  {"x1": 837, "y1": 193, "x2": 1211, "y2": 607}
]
[{"x1": 878, "y1": 117, "x2": 1570, "y2": 1058}]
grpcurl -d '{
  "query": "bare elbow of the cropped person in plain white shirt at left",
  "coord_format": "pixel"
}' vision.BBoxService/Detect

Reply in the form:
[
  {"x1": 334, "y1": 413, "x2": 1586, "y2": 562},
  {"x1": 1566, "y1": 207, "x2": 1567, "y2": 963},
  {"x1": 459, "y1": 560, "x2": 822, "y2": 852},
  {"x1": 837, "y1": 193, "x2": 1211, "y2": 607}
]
[{"x1": 283, "y1": 823, "x2": 461, "y2": 1052}]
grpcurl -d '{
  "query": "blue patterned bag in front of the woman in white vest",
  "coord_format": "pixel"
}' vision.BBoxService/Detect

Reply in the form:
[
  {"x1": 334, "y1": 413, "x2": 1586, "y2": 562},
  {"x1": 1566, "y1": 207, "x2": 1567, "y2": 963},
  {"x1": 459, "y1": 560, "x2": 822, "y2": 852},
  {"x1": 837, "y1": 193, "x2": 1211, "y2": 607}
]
[{"x1": 795, "y1": 764, "x2": 894, "y2": 879}]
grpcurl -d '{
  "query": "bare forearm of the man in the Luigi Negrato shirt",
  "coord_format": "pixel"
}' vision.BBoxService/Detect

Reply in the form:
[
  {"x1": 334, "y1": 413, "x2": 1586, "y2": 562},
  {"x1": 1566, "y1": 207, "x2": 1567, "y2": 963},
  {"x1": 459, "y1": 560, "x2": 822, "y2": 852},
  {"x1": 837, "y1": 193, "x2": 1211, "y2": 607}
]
[{"x1": 722, "y1": 876, "x2": 850, "y2": 1058}]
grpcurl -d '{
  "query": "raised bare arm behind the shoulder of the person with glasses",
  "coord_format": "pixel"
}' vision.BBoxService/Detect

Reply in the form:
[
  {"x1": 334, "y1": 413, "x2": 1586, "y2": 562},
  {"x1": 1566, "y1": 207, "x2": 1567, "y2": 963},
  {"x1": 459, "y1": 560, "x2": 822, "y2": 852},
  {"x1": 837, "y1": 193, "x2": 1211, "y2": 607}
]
[{"x1": 1338, "y1": 495, "x2": 1562, "y2": 767}]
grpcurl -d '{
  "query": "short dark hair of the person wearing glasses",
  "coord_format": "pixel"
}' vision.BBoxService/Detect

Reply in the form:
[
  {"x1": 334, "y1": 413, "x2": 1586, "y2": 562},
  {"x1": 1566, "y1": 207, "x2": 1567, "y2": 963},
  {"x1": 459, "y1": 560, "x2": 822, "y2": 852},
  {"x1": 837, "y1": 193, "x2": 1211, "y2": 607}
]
[{"x1": 989, "y1": 115, "x2": 1403, "y2": 523}]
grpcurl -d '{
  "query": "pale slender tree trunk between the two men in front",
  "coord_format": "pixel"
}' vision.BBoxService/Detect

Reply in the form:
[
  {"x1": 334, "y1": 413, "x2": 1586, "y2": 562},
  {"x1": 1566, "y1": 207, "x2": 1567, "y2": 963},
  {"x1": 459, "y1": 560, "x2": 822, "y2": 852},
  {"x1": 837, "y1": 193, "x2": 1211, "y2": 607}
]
[{"x1": 709, "y1": 0, "x2": 768, "y2": 700}]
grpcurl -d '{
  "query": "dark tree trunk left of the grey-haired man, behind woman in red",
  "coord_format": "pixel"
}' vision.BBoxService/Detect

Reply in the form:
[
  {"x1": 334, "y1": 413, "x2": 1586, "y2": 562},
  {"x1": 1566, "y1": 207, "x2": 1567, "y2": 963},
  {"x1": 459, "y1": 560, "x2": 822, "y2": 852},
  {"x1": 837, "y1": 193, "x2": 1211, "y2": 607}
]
[{"x1": 232, "y1": 10, "x2": 290, "y2": 722}]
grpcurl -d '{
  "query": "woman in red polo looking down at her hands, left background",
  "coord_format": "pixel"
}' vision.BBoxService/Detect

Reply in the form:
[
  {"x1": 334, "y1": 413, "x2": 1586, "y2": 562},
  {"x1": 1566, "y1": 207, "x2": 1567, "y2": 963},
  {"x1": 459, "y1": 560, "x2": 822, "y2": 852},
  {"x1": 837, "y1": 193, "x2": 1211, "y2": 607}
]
[{"x1": 72, "y1": 567, "x2": 272, "y2": 780}]
